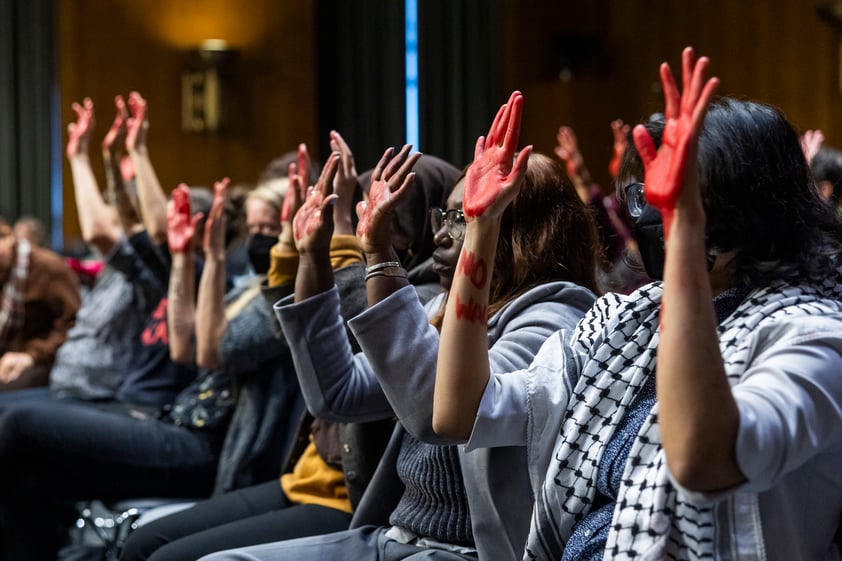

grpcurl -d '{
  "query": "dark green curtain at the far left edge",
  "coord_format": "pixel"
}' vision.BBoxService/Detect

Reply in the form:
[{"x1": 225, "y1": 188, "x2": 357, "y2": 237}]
[{"x1": 0, "y1": 0, "x2": 60, "y2": 245}]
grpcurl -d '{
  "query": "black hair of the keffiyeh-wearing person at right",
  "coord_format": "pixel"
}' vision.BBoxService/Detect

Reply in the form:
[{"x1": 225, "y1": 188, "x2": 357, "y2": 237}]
[{"x1": 618, "y1": 98, "x2": 842, "y2": 286}]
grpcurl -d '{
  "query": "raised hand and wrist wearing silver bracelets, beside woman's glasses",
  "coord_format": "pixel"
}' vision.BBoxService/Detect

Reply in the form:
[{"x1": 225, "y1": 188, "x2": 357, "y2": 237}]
[{"x1": 357, "y1": 144, "x2": 421, "y2": 306}]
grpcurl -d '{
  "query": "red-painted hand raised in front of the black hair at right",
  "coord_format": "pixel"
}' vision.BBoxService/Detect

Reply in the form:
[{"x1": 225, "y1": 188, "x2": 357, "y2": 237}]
[{"x1": 632, "y1": 47, "x2": 719, "y2": 239}]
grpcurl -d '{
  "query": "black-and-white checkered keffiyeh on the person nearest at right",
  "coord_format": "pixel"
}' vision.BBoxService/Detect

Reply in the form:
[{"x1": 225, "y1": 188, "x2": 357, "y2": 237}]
[{"x1": 524, "y1": 277, "x2": 842, "y2": 561}]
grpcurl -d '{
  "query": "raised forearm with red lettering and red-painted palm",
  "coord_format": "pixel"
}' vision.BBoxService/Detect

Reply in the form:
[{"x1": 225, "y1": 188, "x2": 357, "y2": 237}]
[{"x1": 433, "y1": 92, "x2": 532, "y2": 439}]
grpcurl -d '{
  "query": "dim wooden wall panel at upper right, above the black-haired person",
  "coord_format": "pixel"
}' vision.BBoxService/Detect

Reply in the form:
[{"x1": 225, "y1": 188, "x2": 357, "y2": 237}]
[{"x1": 501, "y1": 0, "x2": 842, "y2": 190}]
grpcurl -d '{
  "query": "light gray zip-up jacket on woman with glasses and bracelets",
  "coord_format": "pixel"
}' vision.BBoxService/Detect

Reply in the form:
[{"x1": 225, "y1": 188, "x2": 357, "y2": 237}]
[{"x1": 275, "y1": 282, "x2": 595, "y2": 561}]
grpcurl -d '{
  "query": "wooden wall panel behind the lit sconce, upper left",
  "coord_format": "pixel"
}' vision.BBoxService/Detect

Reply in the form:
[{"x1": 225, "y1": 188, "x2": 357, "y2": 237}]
[{"x1": 58, "y1": 0, "x2": 318, "y2": 243}]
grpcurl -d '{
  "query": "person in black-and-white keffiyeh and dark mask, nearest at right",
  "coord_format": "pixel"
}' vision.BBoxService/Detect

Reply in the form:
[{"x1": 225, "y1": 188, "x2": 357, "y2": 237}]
[{"x1": 434, "y1": 48, "x2": 842, "y2": 561}]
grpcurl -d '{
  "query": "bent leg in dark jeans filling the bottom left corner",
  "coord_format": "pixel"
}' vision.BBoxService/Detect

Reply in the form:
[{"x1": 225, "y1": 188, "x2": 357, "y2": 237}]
[{"x1": 0, "y1": 399, "x2": 222, "y2": 561}]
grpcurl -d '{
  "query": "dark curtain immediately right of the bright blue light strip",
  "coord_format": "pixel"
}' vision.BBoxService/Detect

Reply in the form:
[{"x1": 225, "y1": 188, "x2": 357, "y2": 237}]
[{"x1": 418, "y1": 0, "x2": 496, "y2": 167}]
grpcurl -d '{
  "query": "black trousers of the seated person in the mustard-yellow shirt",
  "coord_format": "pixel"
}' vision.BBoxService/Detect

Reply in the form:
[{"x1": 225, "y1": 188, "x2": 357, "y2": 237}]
[{"x1": 121, "y1": 479, "x2": 351, "y2": 561}]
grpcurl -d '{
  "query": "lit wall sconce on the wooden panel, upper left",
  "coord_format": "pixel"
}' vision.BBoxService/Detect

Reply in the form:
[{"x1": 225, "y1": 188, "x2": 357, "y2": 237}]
[{"x1": 181, "y1": 39, "x2": 235, "y2": 133}]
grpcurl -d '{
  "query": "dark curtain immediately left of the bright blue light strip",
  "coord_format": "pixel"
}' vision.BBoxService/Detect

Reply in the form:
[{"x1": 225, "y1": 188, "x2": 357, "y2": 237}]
[{"x1": 316, "y1": 0, "x2": 406, "y2": 173}]
